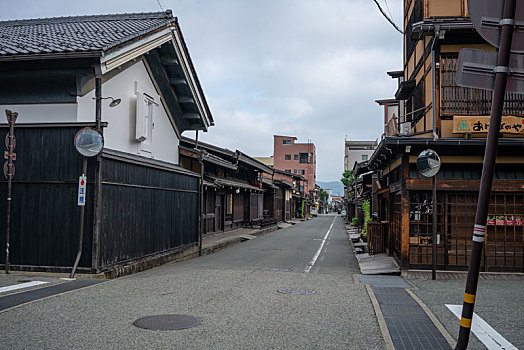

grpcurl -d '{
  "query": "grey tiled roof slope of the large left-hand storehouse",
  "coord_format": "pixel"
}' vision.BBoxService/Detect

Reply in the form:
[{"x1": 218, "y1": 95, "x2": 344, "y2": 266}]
[{"x1": 0, "y1": 10, "x2": 175, "y2": 57}]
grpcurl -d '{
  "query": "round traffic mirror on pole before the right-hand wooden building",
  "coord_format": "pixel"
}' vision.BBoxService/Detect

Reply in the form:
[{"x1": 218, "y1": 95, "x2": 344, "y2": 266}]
[{"x1": 417, "y1": 149, "x2": 440, "y2": 280}]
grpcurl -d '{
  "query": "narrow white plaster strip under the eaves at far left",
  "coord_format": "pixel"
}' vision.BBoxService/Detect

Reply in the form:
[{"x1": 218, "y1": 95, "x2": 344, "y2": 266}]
[{"x1": 0, "y1": 103, "x2": 77, "y2": 124}]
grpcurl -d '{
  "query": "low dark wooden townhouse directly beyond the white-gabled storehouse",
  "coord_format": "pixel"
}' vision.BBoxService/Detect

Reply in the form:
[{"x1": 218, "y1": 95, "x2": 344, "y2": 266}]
[{"x1": 179, "y1": 137, "x2": 276, "y2": 233}]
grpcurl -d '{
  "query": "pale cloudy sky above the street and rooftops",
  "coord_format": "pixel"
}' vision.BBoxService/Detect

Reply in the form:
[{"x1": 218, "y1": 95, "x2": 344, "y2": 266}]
[{"x1": 0, "y1": 0, "x2": 403, "y2": 181}]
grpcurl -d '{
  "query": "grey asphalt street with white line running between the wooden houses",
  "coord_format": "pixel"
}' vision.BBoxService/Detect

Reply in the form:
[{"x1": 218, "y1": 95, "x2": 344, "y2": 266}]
[{"x1": 0, "y1": 216, "x2": 384, "y2": 349}]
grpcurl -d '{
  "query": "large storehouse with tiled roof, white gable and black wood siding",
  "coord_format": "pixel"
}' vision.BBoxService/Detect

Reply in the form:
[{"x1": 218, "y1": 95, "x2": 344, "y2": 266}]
[{"x1": 0, "y1": 10, "x2": 214, "y2": 272}]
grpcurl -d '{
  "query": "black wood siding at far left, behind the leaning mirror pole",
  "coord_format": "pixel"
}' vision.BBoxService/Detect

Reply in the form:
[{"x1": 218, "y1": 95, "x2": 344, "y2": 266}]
[{"x1": 0, "y1": 126, "x2": 95, "y2": 268}]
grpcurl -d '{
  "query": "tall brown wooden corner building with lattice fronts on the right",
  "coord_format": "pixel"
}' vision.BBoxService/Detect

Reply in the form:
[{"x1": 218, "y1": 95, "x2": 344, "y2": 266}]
[{"x1": 368, "y1": 0, "x2": 524, "y2": 272}]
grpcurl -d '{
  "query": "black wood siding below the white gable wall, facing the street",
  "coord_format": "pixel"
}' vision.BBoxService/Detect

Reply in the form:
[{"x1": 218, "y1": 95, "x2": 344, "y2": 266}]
[{"x1": 100, "y1": 159, "x2": 199, "y2": 269}]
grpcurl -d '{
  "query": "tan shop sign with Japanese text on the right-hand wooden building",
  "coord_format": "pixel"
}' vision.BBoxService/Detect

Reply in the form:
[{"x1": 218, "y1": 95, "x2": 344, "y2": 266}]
[{"x1": 453, "y1": 116, "x2": 524, "y2": 134}]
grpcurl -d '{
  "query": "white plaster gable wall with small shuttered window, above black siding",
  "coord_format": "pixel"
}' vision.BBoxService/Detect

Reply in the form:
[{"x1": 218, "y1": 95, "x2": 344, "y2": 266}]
[{"x1": 77, "y1": 61, "x2": 179, "y2": 164}]
